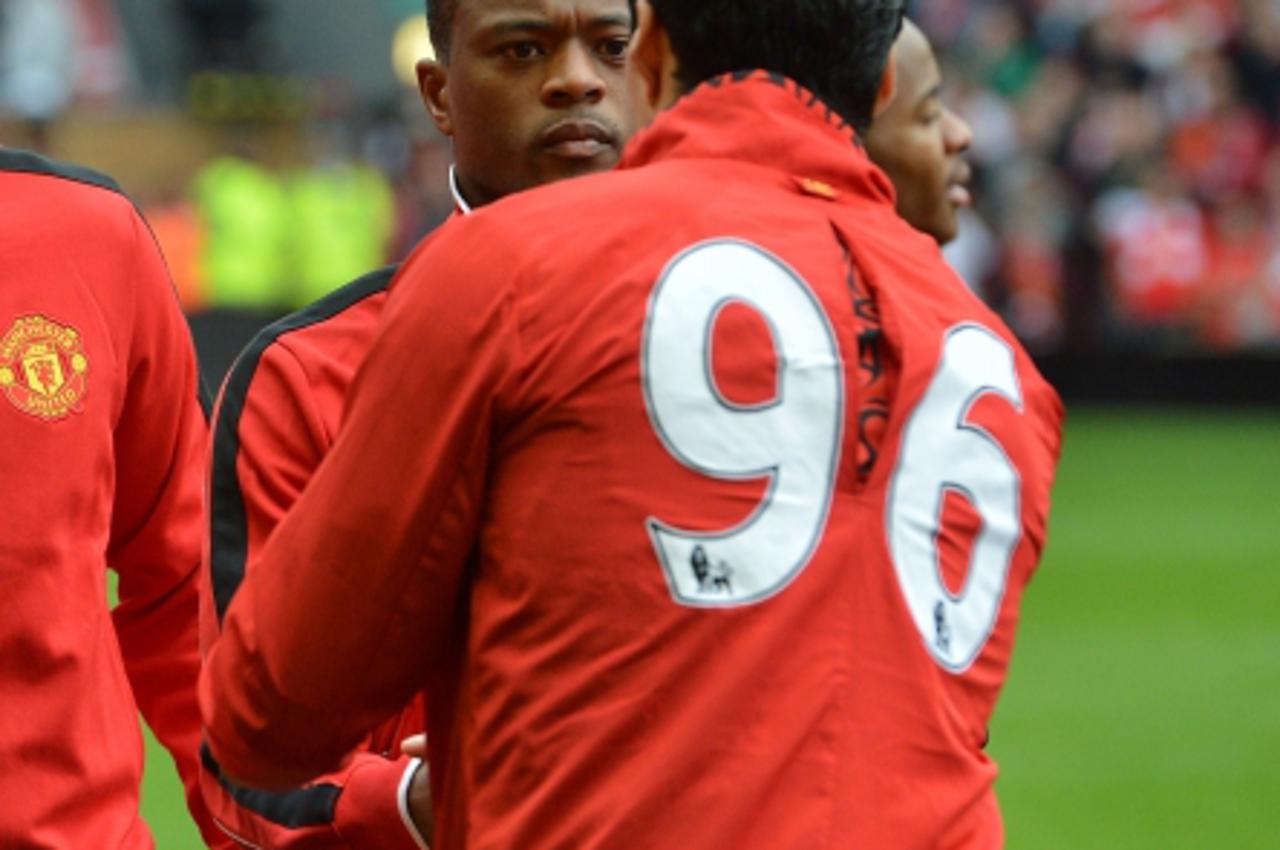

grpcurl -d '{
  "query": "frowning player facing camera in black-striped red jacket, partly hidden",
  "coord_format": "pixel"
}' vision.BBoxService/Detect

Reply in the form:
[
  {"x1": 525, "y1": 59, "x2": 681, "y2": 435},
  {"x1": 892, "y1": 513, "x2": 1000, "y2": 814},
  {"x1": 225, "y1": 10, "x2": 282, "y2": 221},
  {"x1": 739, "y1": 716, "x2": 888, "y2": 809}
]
[{"x1": 193, "y1": 0, "x2": 634, "y2": 850}]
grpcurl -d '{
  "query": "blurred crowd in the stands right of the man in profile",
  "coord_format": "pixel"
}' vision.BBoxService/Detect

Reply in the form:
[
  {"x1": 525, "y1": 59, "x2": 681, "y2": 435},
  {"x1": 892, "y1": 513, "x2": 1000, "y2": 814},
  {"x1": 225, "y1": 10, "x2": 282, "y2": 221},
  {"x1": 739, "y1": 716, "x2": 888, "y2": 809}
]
[{"x1": 914, "y1": 0, "x2": 1280, "y2": 352}]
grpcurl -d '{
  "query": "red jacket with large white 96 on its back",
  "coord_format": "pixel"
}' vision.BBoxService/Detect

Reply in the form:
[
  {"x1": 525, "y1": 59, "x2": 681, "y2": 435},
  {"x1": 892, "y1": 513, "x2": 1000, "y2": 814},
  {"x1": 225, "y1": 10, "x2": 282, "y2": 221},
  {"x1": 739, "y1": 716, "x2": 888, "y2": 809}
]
[{"x1": 201, "y1": 74, "x2": 1061, "y2": 850}]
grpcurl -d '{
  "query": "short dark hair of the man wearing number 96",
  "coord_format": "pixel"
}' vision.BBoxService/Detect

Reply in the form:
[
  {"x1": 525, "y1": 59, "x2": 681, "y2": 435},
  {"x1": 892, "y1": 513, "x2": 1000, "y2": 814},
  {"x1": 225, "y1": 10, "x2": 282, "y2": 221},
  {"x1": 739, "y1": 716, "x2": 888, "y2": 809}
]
[{"x1": 650, "y1": 0, "x2": 905, "y2": 132}]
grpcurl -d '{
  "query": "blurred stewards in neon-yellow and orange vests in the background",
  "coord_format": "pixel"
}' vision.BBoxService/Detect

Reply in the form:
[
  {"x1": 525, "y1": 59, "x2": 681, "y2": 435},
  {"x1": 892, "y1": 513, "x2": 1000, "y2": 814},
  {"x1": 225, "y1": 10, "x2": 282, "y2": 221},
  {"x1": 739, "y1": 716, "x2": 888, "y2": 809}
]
[{"x1": 145, "y1": 116, "x2": 453, "y2": 316}]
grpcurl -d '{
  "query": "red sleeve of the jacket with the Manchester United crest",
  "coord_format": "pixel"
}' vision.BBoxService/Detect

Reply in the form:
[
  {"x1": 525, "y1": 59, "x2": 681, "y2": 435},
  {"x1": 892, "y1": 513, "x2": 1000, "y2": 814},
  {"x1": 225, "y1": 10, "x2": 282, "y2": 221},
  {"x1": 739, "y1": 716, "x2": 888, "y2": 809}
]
[{"x1": 106, "y1": 207, "x2": 229, "y2": 846}]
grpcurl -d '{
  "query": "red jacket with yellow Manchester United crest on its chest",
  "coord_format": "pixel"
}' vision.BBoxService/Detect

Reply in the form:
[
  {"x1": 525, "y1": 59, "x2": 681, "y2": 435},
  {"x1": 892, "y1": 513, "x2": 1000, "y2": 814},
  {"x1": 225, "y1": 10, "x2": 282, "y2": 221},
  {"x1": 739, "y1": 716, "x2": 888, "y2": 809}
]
[{"x1": 0, "y1": 151, "x2": 225, "y2": 850}]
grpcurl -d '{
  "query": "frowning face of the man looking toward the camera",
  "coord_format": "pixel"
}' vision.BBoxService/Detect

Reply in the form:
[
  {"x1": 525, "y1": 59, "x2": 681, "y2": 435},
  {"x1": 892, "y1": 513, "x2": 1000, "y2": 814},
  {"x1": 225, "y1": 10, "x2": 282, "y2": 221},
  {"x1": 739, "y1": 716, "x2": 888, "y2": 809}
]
[{"x1": 424, "y1": 0, "x2": 634, "y2": 204}]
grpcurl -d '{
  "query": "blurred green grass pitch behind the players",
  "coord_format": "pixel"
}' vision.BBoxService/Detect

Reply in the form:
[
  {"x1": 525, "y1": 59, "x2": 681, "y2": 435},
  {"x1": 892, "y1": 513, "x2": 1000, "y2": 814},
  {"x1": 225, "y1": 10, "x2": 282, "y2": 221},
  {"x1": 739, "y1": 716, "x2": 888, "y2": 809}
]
[{"x1": 143, "y1": 408, "x2": 1280, "y2": 850}]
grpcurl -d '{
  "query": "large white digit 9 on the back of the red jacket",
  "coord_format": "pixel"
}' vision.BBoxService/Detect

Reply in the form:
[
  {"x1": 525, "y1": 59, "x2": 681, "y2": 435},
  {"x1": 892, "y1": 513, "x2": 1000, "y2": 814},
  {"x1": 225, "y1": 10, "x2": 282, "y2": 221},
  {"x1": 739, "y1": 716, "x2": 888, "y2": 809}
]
[{"x1": 641, "y1": 239, "x2": 844, "y2": 607}]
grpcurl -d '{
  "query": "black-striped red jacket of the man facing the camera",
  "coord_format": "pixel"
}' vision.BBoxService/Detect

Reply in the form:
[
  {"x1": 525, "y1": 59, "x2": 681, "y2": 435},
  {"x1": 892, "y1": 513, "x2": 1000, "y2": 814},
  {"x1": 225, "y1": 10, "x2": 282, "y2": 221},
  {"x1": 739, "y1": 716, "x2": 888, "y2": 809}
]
[{"x1": 201, "y1": 268, "x2": 425, "y2": 850}]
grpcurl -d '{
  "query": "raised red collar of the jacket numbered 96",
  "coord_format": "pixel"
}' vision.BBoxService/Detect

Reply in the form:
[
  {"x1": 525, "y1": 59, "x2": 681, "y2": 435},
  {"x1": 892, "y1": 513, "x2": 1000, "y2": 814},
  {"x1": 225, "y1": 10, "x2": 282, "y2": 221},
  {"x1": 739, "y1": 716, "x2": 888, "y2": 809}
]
[{"x1": 620, "y1": 70, "x2": 893, "y2": 204}]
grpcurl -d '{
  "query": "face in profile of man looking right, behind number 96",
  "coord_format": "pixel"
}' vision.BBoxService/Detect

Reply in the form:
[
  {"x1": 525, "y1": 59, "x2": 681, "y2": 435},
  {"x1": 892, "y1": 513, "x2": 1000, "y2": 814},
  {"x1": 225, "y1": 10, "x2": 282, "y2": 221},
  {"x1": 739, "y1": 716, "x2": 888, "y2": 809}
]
[{"x1": 867, "y1": 20, "x2": 972, "y2": 245}]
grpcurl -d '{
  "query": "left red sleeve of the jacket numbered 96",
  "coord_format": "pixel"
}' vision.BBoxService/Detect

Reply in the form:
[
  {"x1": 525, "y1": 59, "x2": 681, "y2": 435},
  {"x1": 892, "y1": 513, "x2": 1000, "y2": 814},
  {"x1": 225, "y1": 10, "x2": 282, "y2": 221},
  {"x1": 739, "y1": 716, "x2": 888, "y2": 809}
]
[{"x1": 201, "y1": 219, "x2": 516, "y2": 787}]
